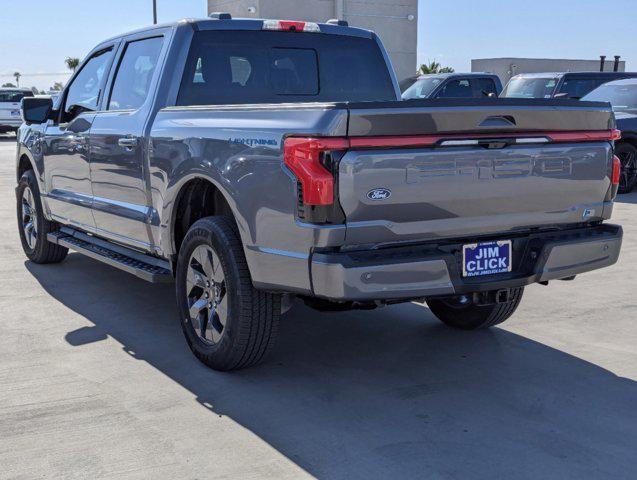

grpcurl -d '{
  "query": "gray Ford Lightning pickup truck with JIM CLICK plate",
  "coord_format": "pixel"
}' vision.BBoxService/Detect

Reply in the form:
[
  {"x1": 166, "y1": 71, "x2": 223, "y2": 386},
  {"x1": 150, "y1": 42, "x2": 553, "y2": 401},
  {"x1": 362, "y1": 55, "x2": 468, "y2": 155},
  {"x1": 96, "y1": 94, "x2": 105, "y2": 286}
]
[{"x1": 17, "y1": 14, "x2": 622, "y2": 370}]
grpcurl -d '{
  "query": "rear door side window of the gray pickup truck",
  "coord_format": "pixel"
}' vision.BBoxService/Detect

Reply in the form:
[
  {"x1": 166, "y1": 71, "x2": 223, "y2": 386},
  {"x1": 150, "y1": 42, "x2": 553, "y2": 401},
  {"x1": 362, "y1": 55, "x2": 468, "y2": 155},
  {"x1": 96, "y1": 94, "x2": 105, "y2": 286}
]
[{"x1": 108, "y1": 37, "x2": 163, "y2": 110}]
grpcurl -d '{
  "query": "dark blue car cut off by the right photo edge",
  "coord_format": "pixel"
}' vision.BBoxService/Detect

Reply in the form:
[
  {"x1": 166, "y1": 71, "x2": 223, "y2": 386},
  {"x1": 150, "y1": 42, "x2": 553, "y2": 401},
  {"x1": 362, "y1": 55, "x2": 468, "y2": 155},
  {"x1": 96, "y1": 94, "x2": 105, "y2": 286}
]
[{"x1": 582, "y1": 78, "x2": 637, "y2": 193}]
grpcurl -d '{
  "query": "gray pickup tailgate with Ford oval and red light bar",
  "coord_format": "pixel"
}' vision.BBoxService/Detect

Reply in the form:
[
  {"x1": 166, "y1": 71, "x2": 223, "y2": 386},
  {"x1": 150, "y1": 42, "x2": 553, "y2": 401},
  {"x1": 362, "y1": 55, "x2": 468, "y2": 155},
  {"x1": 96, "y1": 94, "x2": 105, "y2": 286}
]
[{"x1": 339, "y1": 100, "x2": 614, "y2": 244}]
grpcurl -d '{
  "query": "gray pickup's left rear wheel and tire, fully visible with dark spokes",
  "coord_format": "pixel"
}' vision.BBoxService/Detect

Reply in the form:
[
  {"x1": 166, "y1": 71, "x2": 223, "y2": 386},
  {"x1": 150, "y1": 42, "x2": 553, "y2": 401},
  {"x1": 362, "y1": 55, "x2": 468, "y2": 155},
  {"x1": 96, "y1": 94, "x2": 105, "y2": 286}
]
[{"x1": 176, "y1": 216, "x2": 281, "y2": 371}]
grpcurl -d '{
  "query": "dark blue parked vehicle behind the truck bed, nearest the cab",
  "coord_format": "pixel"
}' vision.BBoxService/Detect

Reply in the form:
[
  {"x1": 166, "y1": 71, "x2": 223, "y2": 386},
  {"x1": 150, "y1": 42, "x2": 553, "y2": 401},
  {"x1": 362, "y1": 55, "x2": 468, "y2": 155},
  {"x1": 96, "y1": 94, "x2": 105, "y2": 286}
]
[{"x1": 402, "y1": 73, "x2": 502, "y2": 100}]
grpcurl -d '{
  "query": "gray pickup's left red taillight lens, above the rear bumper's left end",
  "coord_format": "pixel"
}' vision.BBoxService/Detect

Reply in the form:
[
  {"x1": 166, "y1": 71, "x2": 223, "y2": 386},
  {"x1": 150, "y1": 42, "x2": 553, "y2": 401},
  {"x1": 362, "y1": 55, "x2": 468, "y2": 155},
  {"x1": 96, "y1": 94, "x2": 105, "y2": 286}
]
[{"x1": 283, "y1": 137, "x2": 349, "y2": 205}]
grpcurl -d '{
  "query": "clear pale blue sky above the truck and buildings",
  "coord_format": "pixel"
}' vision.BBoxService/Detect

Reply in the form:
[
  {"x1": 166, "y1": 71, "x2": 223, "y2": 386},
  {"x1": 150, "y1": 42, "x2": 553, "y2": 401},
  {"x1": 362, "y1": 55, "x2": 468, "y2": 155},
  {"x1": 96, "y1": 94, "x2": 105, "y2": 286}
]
[{"x1": 0, "y1": 0, "x2": 637, "y2": 90}]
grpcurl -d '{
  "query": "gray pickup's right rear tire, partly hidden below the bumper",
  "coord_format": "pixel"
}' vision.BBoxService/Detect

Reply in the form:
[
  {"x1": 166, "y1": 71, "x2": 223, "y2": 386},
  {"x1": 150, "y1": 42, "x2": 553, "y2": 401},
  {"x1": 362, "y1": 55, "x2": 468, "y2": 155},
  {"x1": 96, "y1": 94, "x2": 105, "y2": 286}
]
[{"x1": 427, "y1": 287, "x2": 524, "y2": 330}]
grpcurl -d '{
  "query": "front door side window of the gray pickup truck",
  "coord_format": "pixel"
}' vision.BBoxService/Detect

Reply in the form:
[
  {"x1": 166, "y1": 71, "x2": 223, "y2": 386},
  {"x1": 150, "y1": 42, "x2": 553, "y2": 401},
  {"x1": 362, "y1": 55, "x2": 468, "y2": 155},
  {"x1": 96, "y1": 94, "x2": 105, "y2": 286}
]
[{"x1": 63, "y1": 48, "x2": 113, "y2": 122}]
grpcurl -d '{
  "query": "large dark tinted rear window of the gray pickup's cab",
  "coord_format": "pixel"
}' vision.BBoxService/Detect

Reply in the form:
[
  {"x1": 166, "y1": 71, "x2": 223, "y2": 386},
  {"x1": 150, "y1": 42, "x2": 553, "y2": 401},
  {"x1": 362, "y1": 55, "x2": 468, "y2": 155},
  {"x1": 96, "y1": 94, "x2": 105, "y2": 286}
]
[{"x1": 177, "y1": 31, "x2": 396, "y2": 105}]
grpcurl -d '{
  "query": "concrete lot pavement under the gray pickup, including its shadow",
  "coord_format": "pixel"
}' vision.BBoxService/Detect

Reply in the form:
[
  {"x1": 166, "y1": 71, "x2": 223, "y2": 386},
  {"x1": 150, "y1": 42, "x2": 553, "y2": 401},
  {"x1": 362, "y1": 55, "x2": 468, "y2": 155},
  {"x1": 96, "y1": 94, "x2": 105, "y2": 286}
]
[{"x1": 0, "y1": 136, "x2": 637, "y2": 479}]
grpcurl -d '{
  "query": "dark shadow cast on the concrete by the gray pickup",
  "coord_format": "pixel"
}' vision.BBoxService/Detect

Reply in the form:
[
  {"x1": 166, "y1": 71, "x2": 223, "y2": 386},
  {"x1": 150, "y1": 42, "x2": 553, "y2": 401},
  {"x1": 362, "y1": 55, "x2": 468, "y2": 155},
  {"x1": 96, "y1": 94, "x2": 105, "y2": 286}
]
[{"x1": 26, "y1": 254, "x2": 637, "y2": 479}]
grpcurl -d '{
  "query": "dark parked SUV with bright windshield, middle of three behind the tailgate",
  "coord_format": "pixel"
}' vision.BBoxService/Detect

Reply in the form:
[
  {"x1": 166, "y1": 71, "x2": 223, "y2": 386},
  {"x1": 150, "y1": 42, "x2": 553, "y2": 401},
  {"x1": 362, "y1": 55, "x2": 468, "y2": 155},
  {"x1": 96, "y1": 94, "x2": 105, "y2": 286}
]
[{"x1": 500, "y1": 72, "x2": 637, "y2": 100}]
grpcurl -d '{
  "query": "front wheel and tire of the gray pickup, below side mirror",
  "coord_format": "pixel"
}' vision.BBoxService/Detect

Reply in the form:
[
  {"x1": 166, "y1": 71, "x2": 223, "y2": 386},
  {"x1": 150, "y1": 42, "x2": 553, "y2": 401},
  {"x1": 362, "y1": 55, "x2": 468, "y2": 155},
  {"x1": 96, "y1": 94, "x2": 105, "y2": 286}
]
[{"x1": 16, "y1": 170, "x2": 69, "y2": 264}]
